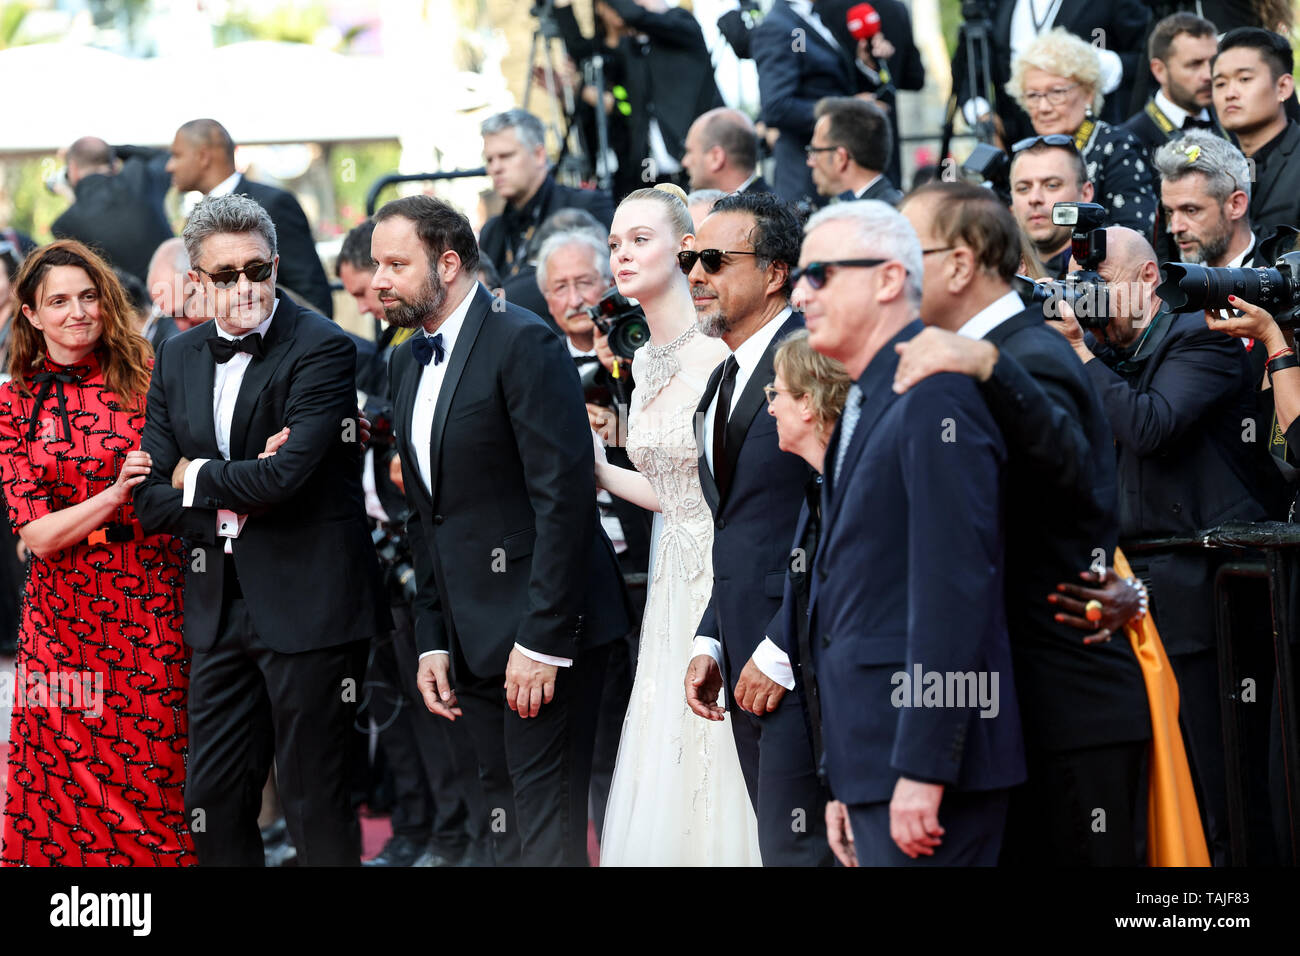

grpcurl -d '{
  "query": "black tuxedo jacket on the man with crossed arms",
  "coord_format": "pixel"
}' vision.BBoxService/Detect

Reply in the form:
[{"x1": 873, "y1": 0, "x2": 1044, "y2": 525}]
[{"x1": 135, "y1": 297, "x2": 393, "y2": 653}]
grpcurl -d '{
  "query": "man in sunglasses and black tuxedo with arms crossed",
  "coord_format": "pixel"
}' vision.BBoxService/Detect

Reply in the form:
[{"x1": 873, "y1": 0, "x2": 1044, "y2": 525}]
[{"x1": 135, "y1": 194, "x2": 393, "y2": 866}]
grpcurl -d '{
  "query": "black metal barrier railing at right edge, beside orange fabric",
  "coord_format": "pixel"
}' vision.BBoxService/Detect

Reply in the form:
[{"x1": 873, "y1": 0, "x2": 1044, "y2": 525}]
[{"x1": 1121, "y1": 522, "x2": 1300, "y2": 866}]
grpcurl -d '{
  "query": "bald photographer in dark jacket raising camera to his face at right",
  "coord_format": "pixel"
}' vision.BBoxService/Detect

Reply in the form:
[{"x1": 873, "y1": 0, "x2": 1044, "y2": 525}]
[{"x1": 1053, "y1": 228, "x2": 1284, "y2": 865}]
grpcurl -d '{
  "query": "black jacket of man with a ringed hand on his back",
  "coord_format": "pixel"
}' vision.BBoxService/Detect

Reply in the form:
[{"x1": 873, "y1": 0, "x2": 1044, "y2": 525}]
[{"x1": 982, "y1": 307, "x2": 1151, "y2": 752}]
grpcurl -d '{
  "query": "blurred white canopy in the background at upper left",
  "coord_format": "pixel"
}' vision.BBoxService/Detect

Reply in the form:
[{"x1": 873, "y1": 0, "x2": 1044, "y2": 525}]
[{"x1": 0, "y1": 42, "x2": 495, "y2": 155}]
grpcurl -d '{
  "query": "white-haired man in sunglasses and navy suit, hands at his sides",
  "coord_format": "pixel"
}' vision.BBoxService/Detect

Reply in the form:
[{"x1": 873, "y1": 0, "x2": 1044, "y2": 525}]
[{"x1": 796, "y1": 202, "x2": 1024, "y2": 866}]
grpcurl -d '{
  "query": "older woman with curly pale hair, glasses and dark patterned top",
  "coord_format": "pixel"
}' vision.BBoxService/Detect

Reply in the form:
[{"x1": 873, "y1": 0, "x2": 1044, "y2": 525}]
[{"x1": 1006, "y1": 27, "x2": 1157, "y2": 235}]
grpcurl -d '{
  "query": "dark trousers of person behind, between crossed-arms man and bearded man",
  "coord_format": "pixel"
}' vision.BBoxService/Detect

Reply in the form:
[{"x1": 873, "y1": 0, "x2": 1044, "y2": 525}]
[{"x1": 371, "y1": 602, "x2": 488, "y2": 858}]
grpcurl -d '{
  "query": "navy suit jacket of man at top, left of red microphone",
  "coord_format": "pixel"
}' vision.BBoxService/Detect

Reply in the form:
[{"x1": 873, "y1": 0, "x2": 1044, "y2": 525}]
[{"x1": 750, "y1": 0, "x2": 861, "y2": 204}]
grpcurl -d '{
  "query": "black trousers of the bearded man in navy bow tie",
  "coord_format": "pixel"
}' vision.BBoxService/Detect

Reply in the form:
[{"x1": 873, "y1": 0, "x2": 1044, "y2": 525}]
[{"x1": 452, "y1": 645, "x2": 610, "y2": 866}]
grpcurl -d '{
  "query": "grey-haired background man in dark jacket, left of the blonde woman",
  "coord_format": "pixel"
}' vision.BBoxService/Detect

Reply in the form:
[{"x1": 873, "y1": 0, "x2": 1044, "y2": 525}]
[{"x1": 478, "y1": 109, "x2": 614, "y2": 313}]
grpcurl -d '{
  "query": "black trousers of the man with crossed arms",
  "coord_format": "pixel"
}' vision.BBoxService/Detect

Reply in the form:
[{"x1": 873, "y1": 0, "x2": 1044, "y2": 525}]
[{"x1": 185, "y1": 590, "x2": 368, "y2": 866}]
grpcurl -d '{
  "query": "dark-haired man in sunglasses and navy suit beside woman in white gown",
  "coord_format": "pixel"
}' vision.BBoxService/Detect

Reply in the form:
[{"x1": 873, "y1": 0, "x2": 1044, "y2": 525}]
[{"x1": 683, "y1": 193, "x2": 831, "y2": 866}]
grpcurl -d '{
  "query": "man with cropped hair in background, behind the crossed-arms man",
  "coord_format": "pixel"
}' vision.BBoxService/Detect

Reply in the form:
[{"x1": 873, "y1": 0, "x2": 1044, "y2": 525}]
[{"x1": 166, "y1": 118, "x2": 334, "y2": 319}]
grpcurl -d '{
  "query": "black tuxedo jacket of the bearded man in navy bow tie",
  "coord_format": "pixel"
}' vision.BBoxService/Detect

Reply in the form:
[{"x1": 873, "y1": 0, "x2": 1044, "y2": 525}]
[{"x1": 389, "y1": 285, "x2": 631, "y2": 676}]
